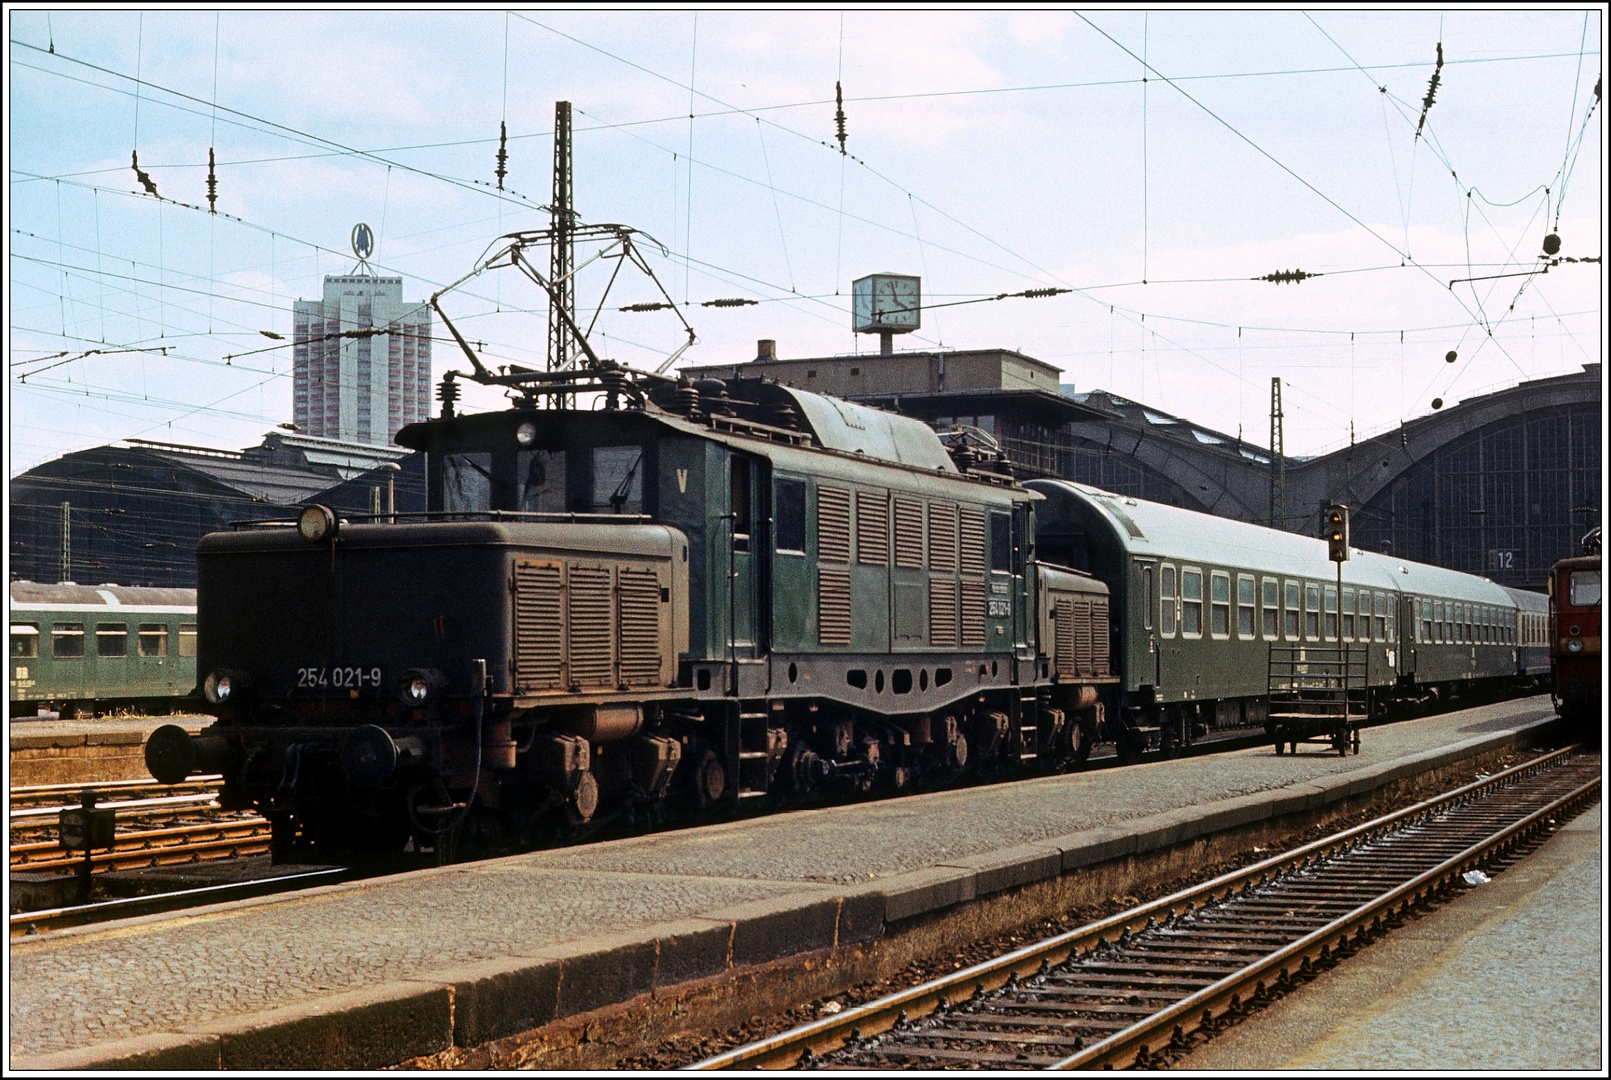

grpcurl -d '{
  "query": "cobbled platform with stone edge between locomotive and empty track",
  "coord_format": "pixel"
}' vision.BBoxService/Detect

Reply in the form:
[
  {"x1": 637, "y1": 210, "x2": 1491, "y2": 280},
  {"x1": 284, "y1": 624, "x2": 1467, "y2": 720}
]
[{"x1": 10, "y1": 698, "x2": 1572, "y2": 1070}]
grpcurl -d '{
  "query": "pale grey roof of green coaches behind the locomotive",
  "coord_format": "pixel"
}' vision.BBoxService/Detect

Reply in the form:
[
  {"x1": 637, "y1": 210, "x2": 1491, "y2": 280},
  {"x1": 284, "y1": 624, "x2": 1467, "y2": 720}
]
[{"x1": 1025, "y1": 480, "x2": 1516, "y2": 608}]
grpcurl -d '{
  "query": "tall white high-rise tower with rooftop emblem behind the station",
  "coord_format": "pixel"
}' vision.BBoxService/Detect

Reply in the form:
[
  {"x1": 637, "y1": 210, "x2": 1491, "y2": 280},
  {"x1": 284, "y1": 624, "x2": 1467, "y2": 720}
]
[{"x1": 292, "y1": 272, "x2": 430, "y2": 445}]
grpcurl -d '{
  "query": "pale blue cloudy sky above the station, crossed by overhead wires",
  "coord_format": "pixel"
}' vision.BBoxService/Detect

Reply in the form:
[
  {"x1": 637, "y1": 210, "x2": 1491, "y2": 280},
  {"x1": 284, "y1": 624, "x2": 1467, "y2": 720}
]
[{"x1": 5, "y1": 6, "x2": 1606, "y2": 476}]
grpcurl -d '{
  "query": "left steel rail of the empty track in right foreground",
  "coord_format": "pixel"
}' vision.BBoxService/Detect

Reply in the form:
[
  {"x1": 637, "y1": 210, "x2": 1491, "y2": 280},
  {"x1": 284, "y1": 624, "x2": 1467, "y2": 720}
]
[{"x1": 688, "y1": 745, "x2": 1579, "y2": 1069}]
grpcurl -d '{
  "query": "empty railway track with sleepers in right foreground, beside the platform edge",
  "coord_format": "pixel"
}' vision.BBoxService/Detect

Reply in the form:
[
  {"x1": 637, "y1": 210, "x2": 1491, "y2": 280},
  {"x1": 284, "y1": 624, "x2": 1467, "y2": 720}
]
[{"x1": 694, "y1": 748, "x2": 1600, "y2": 1069}]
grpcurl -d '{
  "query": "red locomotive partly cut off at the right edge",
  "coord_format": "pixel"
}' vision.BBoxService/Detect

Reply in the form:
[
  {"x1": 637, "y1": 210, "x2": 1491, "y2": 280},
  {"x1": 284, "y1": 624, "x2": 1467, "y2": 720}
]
[{"x1": 1550, "y1": 529, "x2": 1605, "y2": 741}]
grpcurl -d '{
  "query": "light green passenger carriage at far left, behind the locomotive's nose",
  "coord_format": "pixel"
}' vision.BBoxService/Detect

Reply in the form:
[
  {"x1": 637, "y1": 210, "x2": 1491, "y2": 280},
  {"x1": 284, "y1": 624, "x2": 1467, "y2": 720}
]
[{"x1": 10, "y1": 582, "x2": 197, "y2": 721}]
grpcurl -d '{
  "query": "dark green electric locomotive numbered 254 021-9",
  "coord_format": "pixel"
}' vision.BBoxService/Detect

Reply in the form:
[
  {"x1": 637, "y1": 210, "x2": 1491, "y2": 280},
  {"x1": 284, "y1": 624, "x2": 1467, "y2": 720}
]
[{"x1": 147, "y1": 367, "x2": 1113, "y2": 862}]
